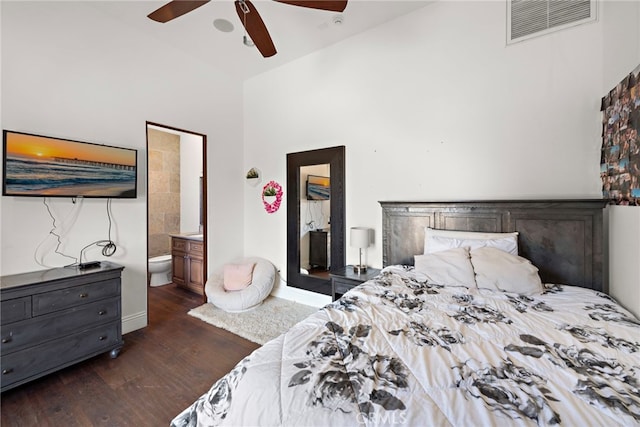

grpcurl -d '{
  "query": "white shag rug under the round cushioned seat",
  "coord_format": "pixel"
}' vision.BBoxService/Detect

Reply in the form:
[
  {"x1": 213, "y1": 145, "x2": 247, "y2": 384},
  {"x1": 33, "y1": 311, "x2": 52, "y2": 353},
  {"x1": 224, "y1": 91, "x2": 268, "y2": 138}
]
[{"x1": 189, "y1": 296, "x2": 319, "y2": 344}]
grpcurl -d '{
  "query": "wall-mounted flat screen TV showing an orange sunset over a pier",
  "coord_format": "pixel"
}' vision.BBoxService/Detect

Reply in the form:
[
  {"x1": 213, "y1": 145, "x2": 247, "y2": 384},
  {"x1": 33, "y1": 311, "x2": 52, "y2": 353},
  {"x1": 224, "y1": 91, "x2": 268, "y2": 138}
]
[{"x1": 2, "y1": 130, "x2": 138, "y2": 199}]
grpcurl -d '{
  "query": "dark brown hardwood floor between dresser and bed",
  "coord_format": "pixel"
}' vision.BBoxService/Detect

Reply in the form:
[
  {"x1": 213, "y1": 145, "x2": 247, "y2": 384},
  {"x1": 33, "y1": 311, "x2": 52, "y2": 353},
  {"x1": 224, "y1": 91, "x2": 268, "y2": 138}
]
[{"x1": 0, "y1": 285, "x2": 259, "y2": 427}]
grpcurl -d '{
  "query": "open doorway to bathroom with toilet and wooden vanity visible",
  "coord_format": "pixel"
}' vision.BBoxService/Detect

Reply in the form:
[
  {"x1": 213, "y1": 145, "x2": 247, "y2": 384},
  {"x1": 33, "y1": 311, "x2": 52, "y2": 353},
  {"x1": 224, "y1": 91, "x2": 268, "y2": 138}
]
[{"x1": 146, "y1": 122, "x2": 207, "y2": 295}]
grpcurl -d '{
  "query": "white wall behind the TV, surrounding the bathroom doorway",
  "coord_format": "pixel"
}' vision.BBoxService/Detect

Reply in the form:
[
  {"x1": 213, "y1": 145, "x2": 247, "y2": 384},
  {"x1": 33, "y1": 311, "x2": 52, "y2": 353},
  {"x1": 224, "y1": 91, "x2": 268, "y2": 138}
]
[{"x1": 0, "y1": 2, "x2": 244, "y2": 332}]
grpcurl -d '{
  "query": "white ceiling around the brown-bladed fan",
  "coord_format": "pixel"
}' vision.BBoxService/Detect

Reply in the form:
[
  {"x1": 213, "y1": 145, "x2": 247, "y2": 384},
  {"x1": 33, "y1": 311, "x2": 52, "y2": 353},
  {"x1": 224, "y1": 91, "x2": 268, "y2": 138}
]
[{"x1": 88, "y1": 0, "x2": 432, "y2": 80}]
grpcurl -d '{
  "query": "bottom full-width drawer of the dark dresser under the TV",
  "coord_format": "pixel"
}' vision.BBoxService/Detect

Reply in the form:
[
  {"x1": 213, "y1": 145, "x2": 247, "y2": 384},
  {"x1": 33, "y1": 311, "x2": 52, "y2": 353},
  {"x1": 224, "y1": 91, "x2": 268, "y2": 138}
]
[{"x1": 0, "y1": 322, "x2": 122, "y2": 389}]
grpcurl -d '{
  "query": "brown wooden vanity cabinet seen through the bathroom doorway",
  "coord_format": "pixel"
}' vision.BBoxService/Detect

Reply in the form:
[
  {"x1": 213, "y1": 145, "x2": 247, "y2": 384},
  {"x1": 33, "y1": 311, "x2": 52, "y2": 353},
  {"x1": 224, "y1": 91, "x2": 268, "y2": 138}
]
[{"x1": 171, "y1": 236, "x2": 204, "y2": 295}]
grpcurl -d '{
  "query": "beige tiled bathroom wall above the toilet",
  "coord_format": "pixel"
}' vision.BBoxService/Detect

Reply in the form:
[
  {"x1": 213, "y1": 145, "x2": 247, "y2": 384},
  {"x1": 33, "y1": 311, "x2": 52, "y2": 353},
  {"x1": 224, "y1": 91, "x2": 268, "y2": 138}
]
[{"x1": 148, "y1": 129, "x2": 180, "y2": 257}]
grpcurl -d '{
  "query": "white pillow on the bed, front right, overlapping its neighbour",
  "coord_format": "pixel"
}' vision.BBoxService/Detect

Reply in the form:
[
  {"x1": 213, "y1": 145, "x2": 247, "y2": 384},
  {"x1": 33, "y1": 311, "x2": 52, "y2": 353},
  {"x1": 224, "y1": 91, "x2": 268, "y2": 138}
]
[{"x1": 469, "y1": 247, "x2": 544, "y2": 295}]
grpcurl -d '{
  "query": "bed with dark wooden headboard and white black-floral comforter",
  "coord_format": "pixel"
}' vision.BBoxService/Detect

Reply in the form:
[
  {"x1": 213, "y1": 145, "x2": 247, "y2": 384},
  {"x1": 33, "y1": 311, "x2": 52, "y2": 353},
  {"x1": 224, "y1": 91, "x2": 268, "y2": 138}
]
[{"x1": 172, "y1": 200, "x2": 640, "y2": 427}]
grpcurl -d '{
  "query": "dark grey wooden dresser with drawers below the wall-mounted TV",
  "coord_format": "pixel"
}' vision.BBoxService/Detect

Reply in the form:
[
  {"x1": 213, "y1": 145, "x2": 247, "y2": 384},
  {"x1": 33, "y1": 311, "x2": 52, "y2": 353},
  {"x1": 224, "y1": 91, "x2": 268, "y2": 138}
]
[{"x1": 0, "y1": 261, "x2": 124, "y2": 391}]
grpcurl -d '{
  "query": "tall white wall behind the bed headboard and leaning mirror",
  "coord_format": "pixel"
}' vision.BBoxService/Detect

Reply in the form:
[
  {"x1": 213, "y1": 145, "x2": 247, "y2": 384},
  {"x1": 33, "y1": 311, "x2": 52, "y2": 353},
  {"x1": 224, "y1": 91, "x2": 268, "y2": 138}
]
[{"x1": 244, "y1": 1, "x2": 639, "y2": 314}]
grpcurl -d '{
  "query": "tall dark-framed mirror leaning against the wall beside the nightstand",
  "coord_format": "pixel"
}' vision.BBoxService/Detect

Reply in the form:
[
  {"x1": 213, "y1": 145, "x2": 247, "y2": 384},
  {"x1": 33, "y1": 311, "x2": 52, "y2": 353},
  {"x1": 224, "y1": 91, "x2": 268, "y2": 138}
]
[{"x1": 287, "y1": 146, "x2": 345, "y2": 295}]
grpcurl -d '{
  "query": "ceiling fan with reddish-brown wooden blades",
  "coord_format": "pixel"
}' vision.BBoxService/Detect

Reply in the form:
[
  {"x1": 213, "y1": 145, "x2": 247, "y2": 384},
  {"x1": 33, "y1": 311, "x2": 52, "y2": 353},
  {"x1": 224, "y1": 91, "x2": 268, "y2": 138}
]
[{"x1": 148, "y1": 0, "x2": 347, "y2": 58}]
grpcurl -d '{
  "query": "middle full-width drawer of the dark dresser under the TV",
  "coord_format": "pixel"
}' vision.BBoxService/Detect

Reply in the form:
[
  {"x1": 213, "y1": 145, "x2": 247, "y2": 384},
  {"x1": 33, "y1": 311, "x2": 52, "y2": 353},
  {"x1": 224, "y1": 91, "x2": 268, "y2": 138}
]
[{"x1": 0, "y1": 297, "x2": 120, "y2": 355}]
